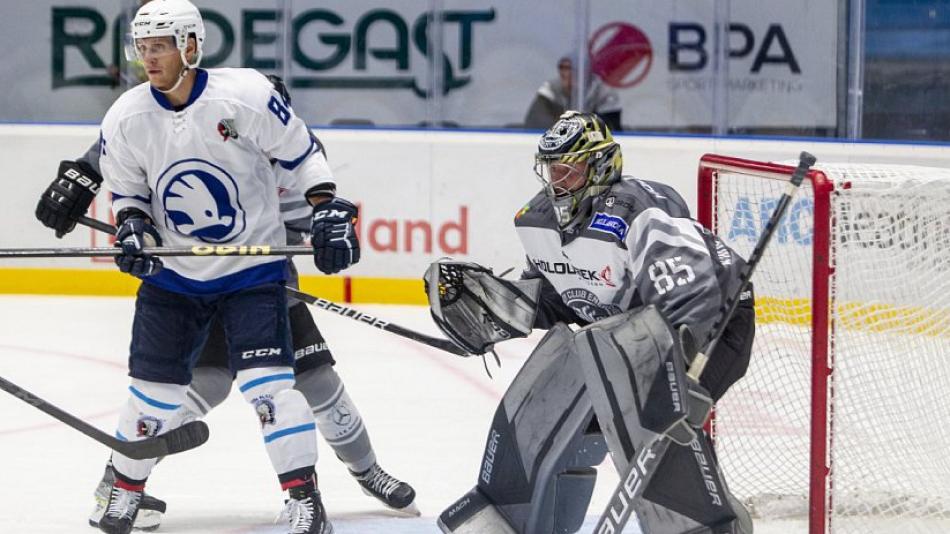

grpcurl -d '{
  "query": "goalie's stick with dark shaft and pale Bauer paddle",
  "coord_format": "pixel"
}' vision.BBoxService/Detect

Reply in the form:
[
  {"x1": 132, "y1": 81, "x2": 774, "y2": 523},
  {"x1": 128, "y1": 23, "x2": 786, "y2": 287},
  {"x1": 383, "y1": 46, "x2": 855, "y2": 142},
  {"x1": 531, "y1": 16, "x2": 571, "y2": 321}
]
[{"x1": 594, "y1": 152, "x2": 815, "y2": 534}]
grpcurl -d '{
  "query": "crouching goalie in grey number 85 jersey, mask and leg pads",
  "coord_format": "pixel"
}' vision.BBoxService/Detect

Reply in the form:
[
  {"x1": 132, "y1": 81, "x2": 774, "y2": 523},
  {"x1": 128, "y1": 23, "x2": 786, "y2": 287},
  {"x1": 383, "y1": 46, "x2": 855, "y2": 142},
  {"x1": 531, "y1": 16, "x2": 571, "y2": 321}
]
[{"x1": 425, "y1": 111, "x2": 755, "y2": 534}]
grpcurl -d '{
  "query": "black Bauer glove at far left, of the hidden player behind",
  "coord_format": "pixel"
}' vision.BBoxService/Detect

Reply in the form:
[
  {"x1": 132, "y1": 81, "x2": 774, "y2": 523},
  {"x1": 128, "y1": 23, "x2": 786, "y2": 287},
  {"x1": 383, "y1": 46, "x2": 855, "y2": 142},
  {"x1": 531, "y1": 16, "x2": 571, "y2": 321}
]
[{"x1": 36, "y1": 161, "x2": 102, "y2": 238}]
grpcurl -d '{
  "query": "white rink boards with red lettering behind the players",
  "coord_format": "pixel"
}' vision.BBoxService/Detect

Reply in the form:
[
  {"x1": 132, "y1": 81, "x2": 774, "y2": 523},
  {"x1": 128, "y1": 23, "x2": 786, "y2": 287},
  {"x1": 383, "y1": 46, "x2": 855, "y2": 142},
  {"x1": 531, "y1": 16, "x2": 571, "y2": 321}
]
[{"x1": 0, "y1": 125, "x2": 950, "y2": 279}]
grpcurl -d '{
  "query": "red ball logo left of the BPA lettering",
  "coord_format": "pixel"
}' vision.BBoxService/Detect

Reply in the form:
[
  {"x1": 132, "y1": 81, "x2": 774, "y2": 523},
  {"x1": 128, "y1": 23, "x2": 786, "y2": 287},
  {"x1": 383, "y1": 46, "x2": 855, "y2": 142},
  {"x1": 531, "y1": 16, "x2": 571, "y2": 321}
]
[{"x1": 587, "y1": 22, "x2": 653, "y2": 87}]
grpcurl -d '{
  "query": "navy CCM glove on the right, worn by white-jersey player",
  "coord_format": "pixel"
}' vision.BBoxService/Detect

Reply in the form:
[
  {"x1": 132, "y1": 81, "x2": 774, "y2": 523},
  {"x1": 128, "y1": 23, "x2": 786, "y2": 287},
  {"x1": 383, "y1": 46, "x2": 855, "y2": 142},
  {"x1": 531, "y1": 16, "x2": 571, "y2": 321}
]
[{"x1": 310, "y1": 197, "x2": 360, "y2": 274}]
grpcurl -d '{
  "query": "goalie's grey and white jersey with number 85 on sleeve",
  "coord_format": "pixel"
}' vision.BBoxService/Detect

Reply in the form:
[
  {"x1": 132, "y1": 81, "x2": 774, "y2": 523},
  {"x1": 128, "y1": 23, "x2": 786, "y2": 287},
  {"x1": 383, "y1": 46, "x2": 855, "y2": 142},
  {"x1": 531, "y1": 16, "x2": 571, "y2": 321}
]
[{"x1": 515, "y1": 176, "x2": 751, "y2": 346}]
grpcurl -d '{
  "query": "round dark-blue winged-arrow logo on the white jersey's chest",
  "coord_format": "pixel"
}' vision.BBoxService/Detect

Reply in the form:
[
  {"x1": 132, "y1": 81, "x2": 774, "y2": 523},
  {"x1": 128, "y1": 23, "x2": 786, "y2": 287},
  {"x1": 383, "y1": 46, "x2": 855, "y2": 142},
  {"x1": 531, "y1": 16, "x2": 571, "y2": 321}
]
[{"x1": 155, "y1": 159, "x2": 245, "y2": 243}]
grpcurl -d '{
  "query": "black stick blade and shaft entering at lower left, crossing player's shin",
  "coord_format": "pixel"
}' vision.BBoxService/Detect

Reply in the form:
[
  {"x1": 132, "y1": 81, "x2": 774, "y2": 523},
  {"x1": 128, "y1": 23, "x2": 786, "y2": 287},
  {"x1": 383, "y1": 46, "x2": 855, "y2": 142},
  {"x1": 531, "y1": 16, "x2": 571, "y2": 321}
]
[{"x1": 0, "y1": 378, "x2": 209, "y2": 460}]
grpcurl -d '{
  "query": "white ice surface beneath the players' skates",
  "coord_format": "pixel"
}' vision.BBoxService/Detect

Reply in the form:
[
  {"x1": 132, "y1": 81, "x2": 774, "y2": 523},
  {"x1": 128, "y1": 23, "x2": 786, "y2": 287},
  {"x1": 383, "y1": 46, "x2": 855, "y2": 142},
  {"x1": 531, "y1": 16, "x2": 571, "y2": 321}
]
[{"x1": 0, "y1": 296, "x2": 805, "y2": 534}]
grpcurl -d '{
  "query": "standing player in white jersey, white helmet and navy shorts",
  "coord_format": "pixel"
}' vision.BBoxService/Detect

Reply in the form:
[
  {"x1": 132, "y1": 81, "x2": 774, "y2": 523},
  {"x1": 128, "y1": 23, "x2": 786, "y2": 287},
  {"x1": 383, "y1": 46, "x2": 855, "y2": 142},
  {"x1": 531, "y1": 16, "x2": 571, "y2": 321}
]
[{"x1": 81, "y1": 0, "x2": 368, "y2": 534}]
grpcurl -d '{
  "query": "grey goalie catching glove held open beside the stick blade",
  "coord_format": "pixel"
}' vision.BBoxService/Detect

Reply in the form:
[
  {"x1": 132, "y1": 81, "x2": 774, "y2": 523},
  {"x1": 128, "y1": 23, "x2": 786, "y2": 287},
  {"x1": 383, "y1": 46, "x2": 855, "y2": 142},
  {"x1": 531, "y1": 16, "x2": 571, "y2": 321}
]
[{"x1": 423, "y1": 260, "x2": 541, "y2": 354}]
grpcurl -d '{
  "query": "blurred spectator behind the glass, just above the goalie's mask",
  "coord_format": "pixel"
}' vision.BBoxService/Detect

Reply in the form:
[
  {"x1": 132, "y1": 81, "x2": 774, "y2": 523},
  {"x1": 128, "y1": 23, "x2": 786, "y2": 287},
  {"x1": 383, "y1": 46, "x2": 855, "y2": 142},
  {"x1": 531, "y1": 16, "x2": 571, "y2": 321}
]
[{"x1": 524, "y1": 56, "x2": 622, "y2": 132}]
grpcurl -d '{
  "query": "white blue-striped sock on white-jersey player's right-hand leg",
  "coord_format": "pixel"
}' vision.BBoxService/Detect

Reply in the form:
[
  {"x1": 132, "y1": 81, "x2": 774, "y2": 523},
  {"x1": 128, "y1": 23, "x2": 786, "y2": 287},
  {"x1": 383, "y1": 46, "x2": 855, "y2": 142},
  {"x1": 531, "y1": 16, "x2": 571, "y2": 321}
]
[{"x1": 235, "y1": 367, "x2": 317, "y2": 474}]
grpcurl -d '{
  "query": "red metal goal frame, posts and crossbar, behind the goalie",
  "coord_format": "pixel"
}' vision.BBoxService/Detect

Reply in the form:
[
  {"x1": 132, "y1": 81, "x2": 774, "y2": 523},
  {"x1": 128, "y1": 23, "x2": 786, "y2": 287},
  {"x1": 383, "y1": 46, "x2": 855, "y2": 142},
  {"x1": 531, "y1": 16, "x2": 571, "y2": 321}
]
[{"x1": 697, "y1": 154, "x2": 847, "y2": 534}]
